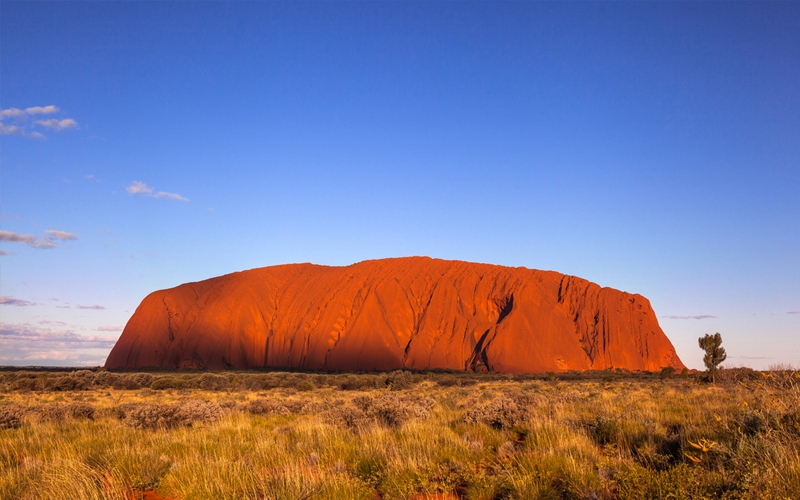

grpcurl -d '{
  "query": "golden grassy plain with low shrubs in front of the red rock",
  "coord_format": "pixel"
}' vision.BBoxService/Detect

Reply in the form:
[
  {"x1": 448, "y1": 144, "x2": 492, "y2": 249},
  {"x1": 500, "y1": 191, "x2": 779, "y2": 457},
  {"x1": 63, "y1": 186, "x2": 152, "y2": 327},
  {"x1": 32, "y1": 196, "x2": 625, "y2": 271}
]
[{"x1": 0, "y1": 369, "x2": 800, "y2": 500}]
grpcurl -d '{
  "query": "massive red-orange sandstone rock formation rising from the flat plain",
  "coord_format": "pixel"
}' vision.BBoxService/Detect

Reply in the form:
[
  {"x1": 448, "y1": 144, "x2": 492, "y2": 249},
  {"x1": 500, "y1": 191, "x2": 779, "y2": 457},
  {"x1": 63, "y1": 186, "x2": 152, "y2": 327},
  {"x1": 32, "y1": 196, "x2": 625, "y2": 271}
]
[{"x1": 106, "y1": 257, "x2": 684, "y2": 373}]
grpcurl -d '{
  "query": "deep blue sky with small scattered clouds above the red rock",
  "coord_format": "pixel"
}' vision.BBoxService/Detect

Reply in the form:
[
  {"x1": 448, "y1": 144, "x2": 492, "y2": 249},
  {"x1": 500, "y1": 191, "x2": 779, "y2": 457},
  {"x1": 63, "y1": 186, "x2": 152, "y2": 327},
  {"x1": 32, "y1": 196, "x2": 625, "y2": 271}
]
[{"x1": 0, "y1": 1, "x2": 800, "y2": 368}]
